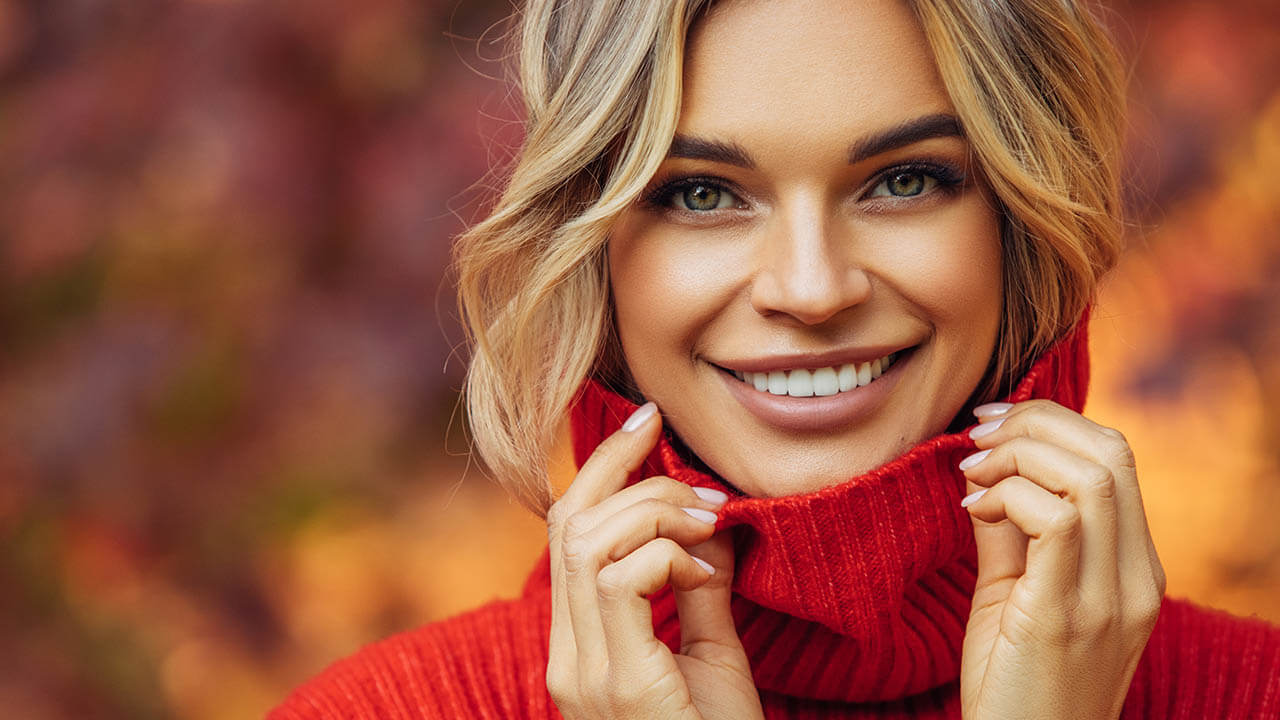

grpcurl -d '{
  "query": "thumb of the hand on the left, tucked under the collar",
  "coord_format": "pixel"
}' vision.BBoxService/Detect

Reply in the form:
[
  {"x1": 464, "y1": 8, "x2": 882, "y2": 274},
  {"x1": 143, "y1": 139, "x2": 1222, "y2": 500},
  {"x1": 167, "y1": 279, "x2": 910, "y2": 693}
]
[{"x1": 675, "y1": 532, "x2": 751, "y2": 676}]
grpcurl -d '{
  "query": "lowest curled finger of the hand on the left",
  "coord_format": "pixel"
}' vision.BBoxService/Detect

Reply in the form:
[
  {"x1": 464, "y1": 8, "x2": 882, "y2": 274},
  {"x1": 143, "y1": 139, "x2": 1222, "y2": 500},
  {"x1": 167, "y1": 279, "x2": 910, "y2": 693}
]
[{"x1": 596, "y1": 538, "x2": 712, "y2": 678}]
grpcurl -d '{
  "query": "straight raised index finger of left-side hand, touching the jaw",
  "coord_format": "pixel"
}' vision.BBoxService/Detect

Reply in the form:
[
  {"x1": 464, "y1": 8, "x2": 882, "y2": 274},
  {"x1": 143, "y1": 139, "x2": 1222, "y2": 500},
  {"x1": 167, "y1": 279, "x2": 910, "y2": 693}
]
[{"x1": 547, "y1": 402, "x2": 662, "y2": 671}]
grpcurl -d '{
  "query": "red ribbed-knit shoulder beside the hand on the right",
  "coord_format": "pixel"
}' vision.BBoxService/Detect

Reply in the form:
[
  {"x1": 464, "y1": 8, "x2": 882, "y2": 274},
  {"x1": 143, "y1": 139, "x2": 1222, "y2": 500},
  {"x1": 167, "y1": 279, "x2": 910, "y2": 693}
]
[{"x1": 1125, "y1": 598, "x2": 1280, "y2": 720}]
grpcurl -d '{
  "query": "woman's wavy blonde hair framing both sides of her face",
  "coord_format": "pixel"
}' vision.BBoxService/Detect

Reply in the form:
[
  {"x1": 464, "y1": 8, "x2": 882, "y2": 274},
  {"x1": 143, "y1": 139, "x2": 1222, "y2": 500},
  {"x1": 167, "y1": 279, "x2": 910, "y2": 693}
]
[{"x1": 454, "y1": 0, "x2": 1124, "y2": 512}]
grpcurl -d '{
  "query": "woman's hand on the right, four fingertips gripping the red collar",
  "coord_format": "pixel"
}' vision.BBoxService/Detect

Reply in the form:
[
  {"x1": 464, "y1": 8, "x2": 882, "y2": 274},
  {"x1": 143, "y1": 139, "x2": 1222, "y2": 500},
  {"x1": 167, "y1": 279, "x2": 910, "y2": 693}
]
[{"x1": 960, "y1": 400, "x2": 1165, "y2": 720}]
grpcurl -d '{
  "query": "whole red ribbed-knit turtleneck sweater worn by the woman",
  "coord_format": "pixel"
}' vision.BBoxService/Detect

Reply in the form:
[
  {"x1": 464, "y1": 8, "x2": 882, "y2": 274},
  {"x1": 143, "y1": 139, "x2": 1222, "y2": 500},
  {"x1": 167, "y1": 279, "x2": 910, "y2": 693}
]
[{"x1": 270, "y1": 324, "x2": 1280, "y2": 720}]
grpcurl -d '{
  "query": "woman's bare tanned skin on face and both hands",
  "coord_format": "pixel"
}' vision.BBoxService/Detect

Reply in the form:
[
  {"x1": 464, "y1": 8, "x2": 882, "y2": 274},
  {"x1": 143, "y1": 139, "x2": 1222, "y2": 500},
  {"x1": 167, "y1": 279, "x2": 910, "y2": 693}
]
[{"x1": 547, "y1": 0, "x2": 1164, "y2": 720}]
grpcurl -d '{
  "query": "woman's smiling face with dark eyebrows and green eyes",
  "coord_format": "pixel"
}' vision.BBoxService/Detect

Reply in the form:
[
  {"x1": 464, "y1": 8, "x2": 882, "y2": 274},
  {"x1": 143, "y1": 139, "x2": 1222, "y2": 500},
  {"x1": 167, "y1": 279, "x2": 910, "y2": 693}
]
[{"x1": 609, "y1": 0, "x2": 1002, "y2": 496}]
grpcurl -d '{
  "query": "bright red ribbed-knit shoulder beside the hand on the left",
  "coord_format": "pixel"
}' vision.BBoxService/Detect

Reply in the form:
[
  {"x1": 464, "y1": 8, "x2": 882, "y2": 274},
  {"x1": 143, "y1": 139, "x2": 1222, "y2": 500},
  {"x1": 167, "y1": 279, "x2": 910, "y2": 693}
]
[{"x1": 268, "y1": 593, "x2": 556, "y2": 720}]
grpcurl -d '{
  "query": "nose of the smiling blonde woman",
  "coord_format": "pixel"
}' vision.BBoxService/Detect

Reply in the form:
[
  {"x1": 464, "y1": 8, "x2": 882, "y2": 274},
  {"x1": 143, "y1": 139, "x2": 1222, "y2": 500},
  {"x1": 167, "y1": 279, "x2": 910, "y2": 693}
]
[{"x1": 750, "y1": 198, "x2": 872, "y2": 325}]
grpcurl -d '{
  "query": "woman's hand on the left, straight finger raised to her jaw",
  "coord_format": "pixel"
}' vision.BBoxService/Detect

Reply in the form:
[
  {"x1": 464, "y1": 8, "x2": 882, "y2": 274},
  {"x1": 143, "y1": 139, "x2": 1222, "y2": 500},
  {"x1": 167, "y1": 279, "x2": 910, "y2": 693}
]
[{"x1": 547, "y1": 402, "x2": 764, "y2": 720}]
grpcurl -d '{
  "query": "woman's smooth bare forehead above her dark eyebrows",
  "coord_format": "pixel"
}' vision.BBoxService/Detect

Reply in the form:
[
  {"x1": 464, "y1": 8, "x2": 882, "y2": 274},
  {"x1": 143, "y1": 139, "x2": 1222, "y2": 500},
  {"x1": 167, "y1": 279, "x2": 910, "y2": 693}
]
[{"x1": 678, "y1": 0, "x2": 952, "y2": 150}]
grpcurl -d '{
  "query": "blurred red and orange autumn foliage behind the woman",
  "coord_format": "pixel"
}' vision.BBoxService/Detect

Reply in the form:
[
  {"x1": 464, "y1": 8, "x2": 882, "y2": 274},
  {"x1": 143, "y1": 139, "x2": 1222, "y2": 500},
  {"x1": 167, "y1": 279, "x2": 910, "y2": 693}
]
[{"x1": 0, "y1": 0, "x2": 1280, "y2": 720}]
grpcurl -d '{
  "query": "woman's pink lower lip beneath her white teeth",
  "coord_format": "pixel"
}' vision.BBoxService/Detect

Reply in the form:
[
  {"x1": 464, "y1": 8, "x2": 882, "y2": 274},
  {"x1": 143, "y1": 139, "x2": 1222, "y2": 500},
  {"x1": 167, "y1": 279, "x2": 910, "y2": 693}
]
[{"x1": 716, "y1": 351, "x2": 915, "y2": 432}]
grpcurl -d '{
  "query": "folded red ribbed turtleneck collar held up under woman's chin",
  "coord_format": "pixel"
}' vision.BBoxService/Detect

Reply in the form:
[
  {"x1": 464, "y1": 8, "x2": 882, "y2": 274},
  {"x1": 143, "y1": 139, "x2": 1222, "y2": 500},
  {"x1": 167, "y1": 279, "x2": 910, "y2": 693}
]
[{"x1": 571, "y1": 313, "x2": 1089, "y2": 702}]
